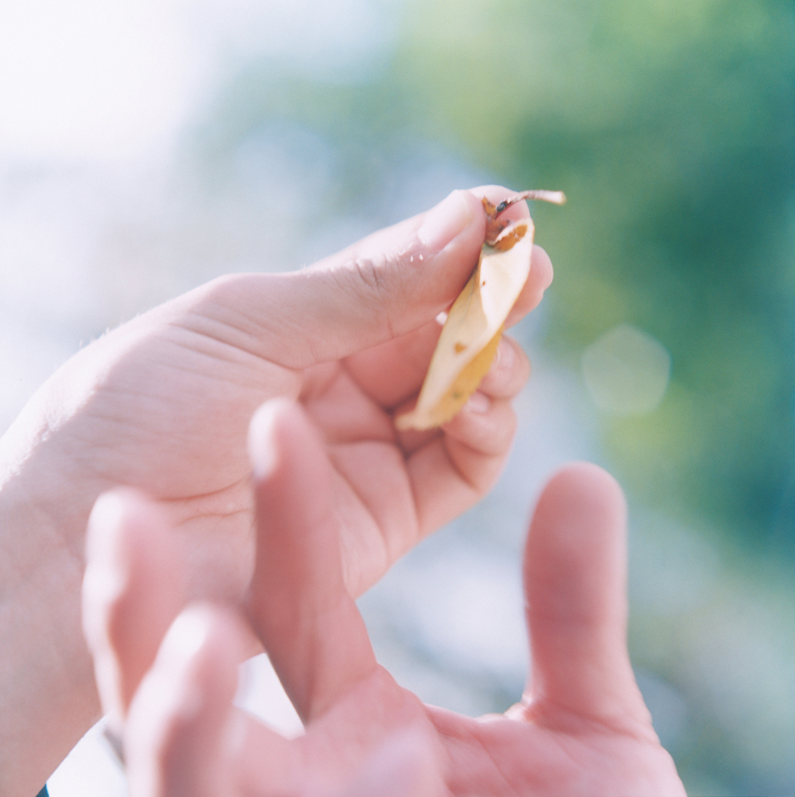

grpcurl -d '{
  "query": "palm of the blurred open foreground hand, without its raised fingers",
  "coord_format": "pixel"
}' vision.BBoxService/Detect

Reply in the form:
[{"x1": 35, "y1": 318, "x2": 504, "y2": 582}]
[{"x1": 218, "y1": 669, "x2": 682, "y2": 797}]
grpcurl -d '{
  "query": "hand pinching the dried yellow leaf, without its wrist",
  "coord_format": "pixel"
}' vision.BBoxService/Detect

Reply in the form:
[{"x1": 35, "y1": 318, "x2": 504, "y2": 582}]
[{"x1": 6, "y1": 187, "x2": 551, "y2": 596}]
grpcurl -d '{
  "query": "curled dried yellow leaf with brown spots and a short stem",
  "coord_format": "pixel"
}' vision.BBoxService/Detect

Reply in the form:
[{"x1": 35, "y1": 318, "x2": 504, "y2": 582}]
[{"x1": 395, "y1": 191, "x2": 565, "y2": 429}]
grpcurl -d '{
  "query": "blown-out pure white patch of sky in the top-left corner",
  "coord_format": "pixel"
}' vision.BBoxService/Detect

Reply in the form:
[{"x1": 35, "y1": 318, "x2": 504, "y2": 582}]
[{"x1": 0, "y1": 0, "x2": 200, "y2": 161}]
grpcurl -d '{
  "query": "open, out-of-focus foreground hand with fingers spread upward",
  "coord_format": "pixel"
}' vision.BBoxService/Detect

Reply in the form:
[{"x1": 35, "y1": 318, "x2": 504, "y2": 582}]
[{"x1": 84, "y1": 404, "x2": 684, "y2": 797}]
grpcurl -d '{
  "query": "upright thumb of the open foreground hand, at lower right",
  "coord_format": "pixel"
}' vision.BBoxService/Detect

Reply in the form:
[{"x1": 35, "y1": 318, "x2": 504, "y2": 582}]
[{"x1": 524, "y1": 463, "x2": 648, "y2": 722}]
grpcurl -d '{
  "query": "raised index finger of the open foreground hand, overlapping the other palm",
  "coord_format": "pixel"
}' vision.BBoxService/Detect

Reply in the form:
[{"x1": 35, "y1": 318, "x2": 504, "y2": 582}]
[{"x1": 249, "y1": 400, "x2": 376, "y2": 723}]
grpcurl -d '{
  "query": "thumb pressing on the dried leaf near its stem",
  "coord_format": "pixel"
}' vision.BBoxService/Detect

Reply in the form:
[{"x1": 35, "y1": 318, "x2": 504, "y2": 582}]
[{"x1": 191, "y1": 188, "x2": 498, "y2": 368}]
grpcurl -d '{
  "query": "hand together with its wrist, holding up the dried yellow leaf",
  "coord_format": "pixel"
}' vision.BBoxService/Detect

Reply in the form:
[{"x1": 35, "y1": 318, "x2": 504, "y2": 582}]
[{"x1": 0, "y1": 186, "x2": 552, "y2": 797}]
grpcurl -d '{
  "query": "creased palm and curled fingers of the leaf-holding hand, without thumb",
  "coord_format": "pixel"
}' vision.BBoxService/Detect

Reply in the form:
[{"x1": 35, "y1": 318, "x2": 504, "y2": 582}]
[{"x1": 65, "y1": 308, "x2": 524, "y2": 595}]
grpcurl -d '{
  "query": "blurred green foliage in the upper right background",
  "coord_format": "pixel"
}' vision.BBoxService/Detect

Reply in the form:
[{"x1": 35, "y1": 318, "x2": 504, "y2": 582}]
[{"x1": 397, "y1": 0, "x2": 795, "y2": 553}]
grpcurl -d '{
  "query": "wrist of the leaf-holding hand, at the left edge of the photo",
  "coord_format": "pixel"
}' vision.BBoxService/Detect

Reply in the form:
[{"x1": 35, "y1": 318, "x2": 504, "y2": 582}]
[{"x1": 0, "y1": 408, "x2": 104, "y2": 797}]
